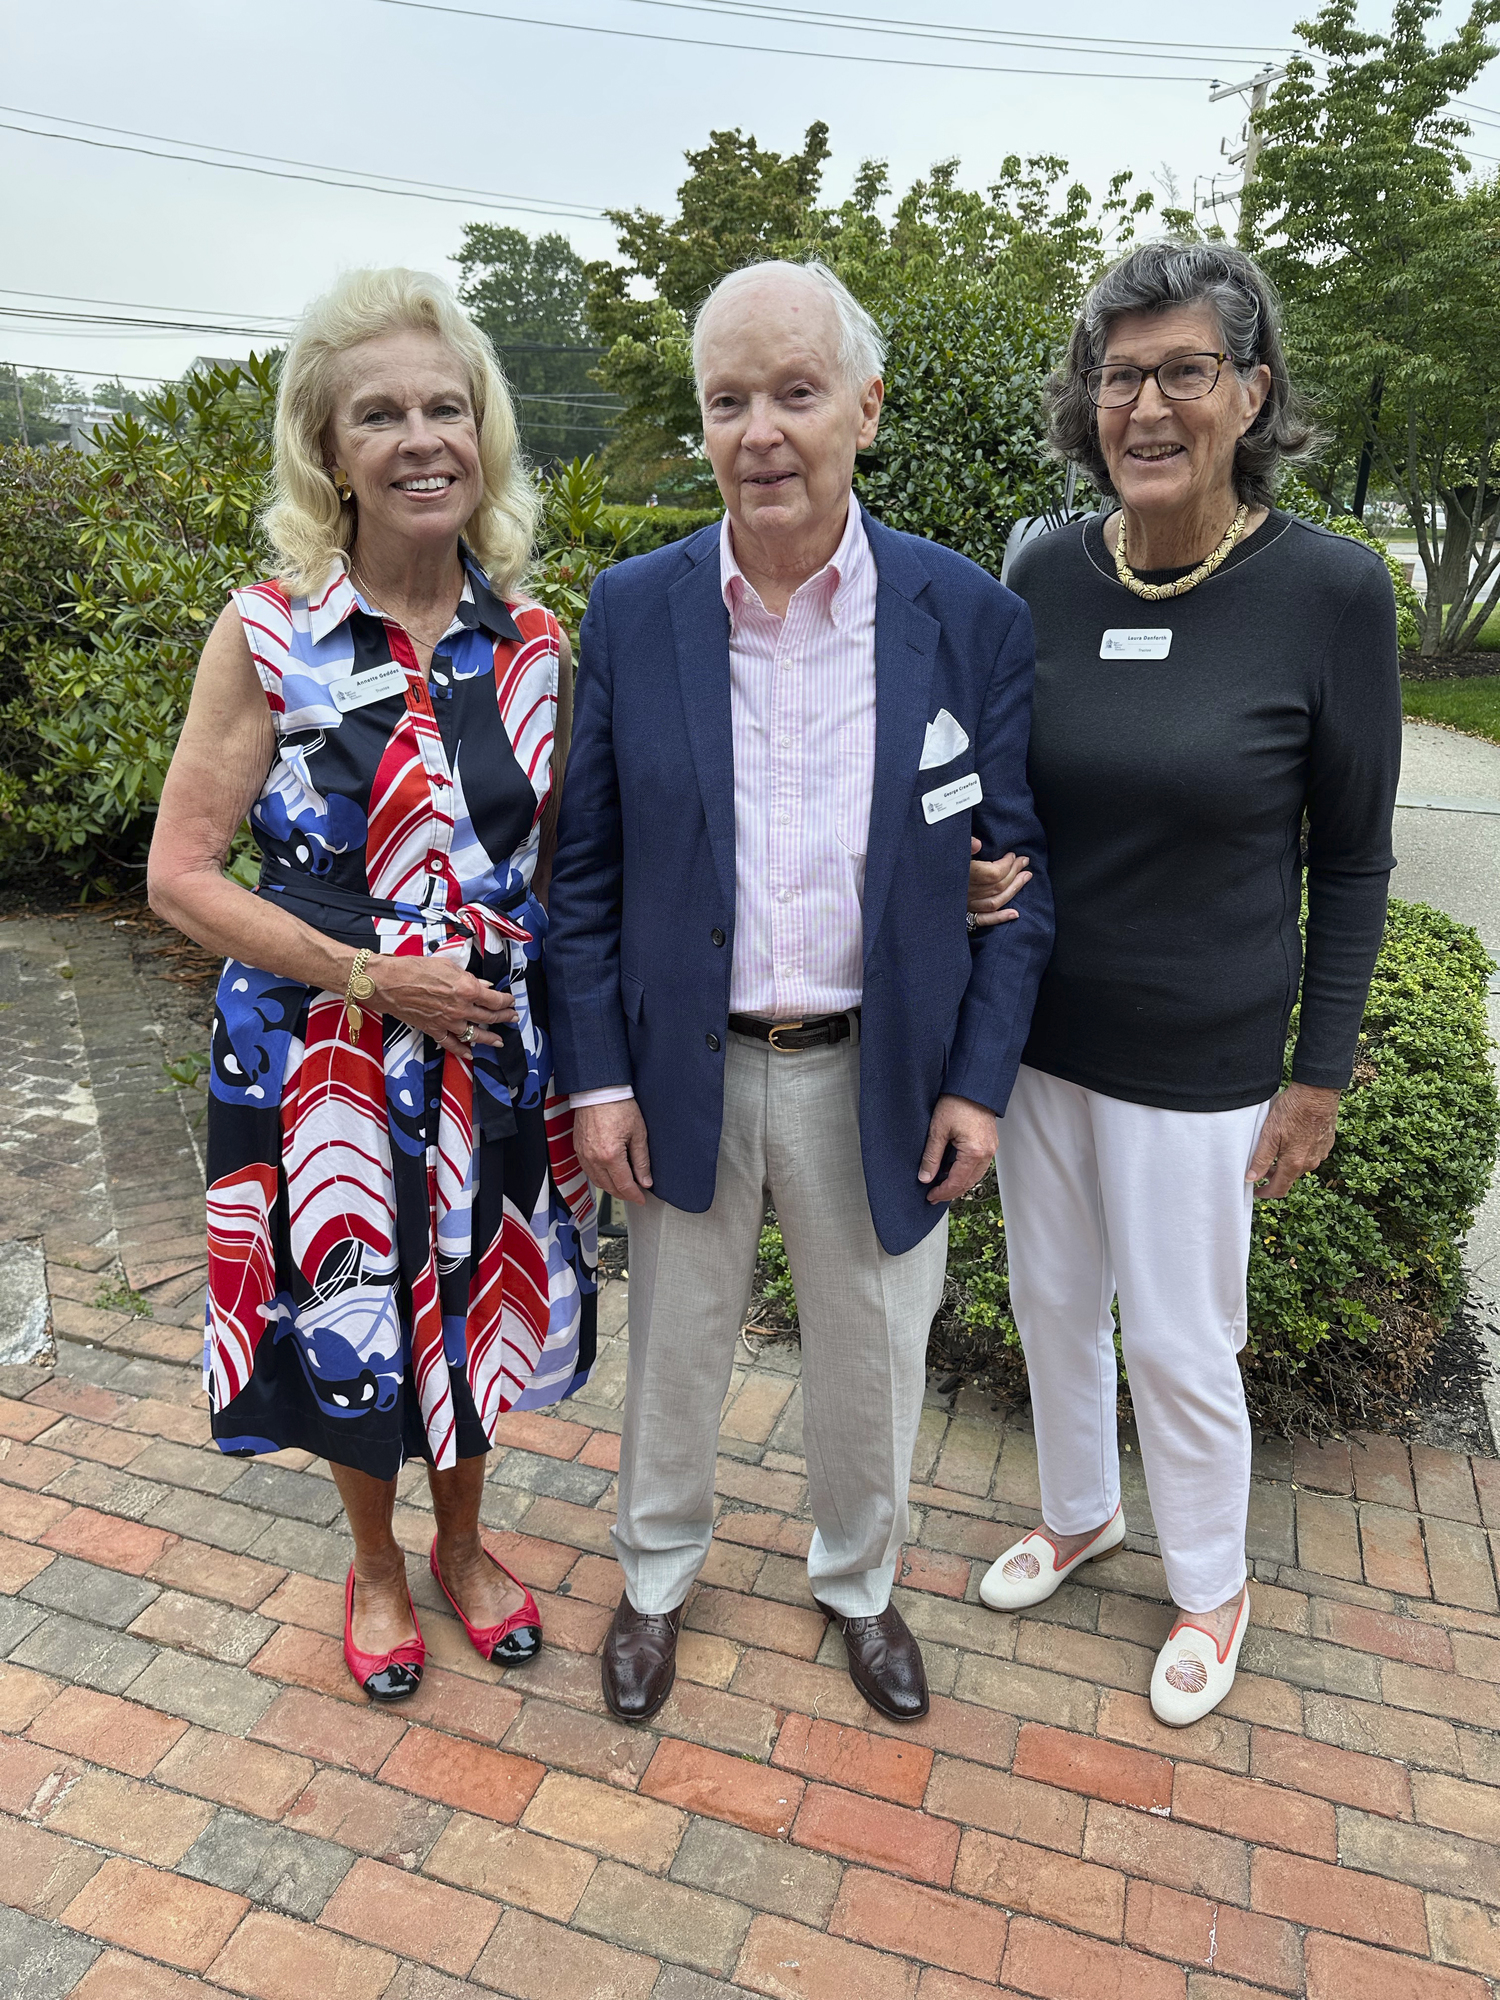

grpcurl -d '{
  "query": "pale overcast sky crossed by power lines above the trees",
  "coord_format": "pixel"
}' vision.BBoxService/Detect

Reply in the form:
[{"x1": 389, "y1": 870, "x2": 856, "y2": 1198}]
[{"x1": 0, "y1": 0, "x2": 1500, "y2": 388}]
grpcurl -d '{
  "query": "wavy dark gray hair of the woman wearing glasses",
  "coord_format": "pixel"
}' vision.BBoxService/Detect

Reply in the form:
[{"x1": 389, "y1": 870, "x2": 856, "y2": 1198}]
[{"x1": 1046, "y1": 240, "x2": 1316, "y2": 506}]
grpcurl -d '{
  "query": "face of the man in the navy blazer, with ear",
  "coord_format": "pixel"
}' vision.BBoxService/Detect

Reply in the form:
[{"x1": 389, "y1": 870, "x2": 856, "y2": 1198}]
[{"x1": 700, "y1": 272, "x2": 884, "y2": 542}]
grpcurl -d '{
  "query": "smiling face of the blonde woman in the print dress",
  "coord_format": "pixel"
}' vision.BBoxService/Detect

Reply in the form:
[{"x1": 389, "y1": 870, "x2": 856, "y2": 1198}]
[{"x1": 324, "y1": 332, "x2": 484, "y2": 542}]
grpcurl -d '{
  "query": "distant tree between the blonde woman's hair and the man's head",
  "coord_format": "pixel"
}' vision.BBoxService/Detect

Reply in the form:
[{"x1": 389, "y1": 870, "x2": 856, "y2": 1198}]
[{"x1": 454, "y1": 222, "x2": 618, "y2": 462}]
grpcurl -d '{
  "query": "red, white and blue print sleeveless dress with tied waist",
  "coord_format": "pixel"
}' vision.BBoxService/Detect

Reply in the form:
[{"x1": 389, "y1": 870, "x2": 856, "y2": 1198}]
[{"x1": 204, "y1": 554, "x2": 596, "y2": 1478}]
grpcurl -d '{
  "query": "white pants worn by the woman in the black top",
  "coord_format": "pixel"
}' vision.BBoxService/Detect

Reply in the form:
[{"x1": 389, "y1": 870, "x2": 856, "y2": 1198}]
[{"x1": 996, "y1": 1066, "x2": 1270, "y2": 1612}]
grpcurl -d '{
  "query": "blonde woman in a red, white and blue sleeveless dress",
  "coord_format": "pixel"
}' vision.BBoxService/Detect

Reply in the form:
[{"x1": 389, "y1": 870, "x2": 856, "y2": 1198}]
[{"x1": 150, "y1": 270, "x2": 594, "y2": 1702}]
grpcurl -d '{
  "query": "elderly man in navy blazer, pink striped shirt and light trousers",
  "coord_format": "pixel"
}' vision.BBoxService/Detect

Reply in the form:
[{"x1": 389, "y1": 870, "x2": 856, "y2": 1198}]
[{"x1": 548, "y1": 264, "x2": 1052, "y2": 1720}]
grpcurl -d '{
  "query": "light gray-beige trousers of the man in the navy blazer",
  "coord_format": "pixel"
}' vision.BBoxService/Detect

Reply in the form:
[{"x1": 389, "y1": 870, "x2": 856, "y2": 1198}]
[{"x1": 614, "y1": 1034, "x2": 948, "y2": 1618}]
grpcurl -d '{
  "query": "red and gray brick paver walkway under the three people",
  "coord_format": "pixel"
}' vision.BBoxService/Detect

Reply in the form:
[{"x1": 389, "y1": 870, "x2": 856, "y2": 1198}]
[{"x1": 0, "y1": 926, "x2": 1500, "y2": 2000}]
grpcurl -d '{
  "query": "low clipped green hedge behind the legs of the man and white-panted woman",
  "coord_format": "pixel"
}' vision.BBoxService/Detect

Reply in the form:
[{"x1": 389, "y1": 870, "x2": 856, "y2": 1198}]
[{"x1": 758, "y1": 902, "x2": 1500, "y2": 1434}]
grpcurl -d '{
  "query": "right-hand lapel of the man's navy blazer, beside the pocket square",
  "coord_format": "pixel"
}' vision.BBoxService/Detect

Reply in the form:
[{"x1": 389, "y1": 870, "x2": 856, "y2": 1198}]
[{"x1": 864, "y1": 552, "x2": 938, "y2": 958}]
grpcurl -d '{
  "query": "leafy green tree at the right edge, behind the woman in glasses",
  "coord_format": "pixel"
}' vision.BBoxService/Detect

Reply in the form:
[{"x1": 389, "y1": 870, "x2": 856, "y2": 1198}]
[{"x1": 1244, "y1": 0, "x2": 1500, "y2": 654}]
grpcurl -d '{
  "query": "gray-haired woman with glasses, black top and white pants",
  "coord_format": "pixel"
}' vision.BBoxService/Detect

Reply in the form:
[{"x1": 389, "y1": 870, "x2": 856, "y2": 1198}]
[{"x1": 980, "y1": 242, "x2": 1400, "y2": 1724}]
